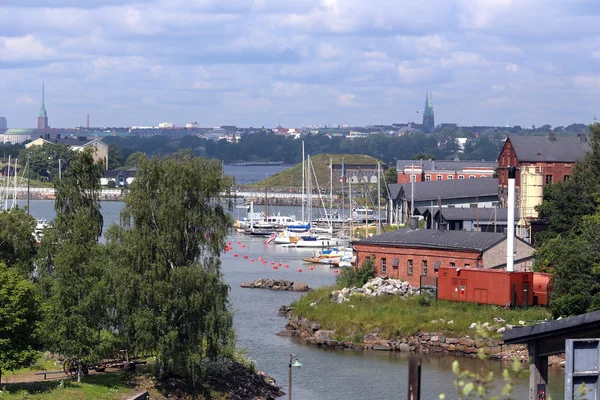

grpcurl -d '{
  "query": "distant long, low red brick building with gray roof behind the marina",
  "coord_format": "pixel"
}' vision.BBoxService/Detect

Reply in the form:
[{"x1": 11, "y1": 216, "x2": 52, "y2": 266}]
[{"x1": 396, "y1": 160, "x2": 498, "y2": 183}]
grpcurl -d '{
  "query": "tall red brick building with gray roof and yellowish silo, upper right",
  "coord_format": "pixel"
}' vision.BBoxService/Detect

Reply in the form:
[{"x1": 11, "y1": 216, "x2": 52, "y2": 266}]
[{"x1": 498, "y1": 133, "x2": 591, "y2": 206}]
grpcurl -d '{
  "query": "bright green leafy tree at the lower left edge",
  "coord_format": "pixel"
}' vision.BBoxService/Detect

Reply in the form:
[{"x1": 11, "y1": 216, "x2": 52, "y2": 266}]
[{"x1": 0, "y1": 263, "x2": 41, "y2": 372}]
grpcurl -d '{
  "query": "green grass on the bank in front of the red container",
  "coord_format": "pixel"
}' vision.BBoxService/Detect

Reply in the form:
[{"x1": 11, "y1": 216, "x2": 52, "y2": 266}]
[{"x1": 294, "y1": 286, "x2": 551, "y2": 343}]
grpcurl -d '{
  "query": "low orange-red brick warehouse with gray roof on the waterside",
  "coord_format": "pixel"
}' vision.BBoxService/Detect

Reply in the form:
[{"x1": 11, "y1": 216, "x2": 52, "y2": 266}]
[{"x1": 352, "y1": 229, "x2": 534, "y2": 286}]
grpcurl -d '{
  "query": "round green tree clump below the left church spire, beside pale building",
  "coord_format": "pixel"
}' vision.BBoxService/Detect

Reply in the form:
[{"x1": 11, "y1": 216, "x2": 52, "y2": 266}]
[{"x1": 19, "y1": 143, "x2": 75, "y2": 181}]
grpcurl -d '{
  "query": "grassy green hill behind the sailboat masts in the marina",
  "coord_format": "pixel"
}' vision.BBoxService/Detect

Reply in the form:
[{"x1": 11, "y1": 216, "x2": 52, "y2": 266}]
[{"x1": 250, "y1": 154, "x2": 383, "y2": 189}]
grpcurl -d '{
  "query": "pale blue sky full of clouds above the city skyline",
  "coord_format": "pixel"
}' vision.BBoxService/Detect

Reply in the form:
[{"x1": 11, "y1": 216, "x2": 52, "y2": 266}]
[{"x1": 0, "y1": 0, "x2": 600, "y2": 127}]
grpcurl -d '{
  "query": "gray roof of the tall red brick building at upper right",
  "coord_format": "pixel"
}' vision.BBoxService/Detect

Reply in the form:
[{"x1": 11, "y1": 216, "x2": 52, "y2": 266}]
[{"x1": 507, "y1": 136, "x2": 592, "y2": 162}]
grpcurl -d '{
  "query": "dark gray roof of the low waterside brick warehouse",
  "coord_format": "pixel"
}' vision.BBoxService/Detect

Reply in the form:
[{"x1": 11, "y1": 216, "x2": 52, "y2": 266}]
[{"x1": 354, "y1": 229, "x2": 506, "y2": 251}]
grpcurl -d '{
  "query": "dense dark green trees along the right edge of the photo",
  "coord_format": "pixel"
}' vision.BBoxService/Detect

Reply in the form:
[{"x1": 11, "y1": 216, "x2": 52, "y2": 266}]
[{"x1": 534, "y1": 123, "x2": 600, "y2": 317}]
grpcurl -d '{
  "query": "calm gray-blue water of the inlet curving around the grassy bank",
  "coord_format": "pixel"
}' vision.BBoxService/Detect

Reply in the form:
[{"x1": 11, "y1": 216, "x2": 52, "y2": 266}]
[{"x1": 21, "y1": 201, "x2": 564, "y2": 400}]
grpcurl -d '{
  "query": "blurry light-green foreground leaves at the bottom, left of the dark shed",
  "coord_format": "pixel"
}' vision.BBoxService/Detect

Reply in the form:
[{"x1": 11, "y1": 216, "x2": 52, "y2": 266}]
[{"x1": 439, "y1": 324, "x2": 528, "y2": 400}]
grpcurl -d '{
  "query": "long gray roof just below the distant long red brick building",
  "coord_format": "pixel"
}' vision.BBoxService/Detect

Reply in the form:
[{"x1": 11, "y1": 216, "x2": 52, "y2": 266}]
[{"x1": 389, "y1": 178, "x2": 498, "y2": 201}]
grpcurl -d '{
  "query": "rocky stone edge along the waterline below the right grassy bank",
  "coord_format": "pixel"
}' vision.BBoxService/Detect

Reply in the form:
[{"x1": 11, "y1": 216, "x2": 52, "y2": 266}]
[{"x1": 277, "y1": 306, "x2": 564, "y2": 367}]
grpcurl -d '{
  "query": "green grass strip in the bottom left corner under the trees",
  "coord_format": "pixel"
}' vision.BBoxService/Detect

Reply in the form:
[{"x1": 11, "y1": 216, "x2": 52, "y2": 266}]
[{"x1": 0, "y1": 372, "x2": 135, "y2": 400}]
